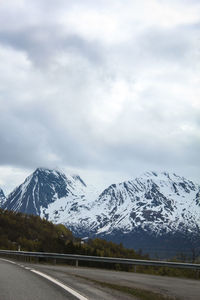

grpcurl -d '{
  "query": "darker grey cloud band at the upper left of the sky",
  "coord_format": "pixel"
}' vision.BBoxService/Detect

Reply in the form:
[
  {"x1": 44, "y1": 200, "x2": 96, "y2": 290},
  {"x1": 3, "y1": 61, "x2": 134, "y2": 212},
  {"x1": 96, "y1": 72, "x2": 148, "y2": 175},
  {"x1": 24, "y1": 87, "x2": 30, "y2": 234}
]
[{"x1": 0, "y1": 25, "x2": 102, "y2": 66}]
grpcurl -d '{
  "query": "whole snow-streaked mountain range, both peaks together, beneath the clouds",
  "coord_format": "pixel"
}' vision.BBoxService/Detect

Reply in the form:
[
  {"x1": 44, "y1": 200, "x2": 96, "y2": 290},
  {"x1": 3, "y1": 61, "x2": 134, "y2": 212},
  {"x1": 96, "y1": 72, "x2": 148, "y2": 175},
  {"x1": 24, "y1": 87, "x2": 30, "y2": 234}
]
[{"x1": 4, "y1": 168, "x2": 200, "y2": 256}]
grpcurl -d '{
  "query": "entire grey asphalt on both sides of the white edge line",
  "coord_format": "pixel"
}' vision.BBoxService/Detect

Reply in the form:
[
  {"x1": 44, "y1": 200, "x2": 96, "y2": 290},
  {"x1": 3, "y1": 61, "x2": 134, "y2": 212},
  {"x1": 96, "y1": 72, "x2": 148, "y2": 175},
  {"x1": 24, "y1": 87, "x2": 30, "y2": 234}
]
[{"x1": 0, "y1": 259, "x2": 200, "y2": 300}]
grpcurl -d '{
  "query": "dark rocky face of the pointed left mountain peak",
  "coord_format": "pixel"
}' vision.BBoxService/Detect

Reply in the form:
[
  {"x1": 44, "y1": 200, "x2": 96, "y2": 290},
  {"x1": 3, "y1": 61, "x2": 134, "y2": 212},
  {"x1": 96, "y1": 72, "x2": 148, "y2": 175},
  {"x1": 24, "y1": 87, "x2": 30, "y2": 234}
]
[{"x1": 4, "y1": 168, "x2": 85, "y2": 215}]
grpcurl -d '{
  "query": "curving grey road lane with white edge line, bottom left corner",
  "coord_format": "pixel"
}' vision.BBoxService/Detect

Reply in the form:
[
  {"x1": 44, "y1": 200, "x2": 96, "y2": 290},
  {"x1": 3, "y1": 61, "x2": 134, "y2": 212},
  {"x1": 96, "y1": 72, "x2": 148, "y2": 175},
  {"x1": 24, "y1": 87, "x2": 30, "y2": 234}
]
[{"x1": 0, "y1": 259, "x2": 136, "y2": 300}]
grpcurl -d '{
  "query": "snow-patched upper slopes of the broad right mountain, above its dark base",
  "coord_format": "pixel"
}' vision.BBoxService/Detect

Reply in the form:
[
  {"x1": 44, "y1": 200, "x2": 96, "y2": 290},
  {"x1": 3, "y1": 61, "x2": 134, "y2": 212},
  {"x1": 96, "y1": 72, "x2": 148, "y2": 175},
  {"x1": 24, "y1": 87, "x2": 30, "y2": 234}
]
[{"x1": 72, "y1": 172, "x2": 200, "y2": 239}]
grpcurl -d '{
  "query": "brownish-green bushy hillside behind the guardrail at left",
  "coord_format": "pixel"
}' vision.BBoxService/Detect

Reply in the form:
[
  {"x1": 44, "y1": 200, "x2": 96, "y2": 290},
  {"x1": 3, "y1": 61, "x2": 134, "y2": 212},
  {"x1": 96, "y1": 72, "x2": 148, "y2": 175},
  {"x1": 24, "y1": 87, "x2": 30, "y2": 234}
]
[{"x1": 0, "y1": 209, "x2": 148, "y2": 259}]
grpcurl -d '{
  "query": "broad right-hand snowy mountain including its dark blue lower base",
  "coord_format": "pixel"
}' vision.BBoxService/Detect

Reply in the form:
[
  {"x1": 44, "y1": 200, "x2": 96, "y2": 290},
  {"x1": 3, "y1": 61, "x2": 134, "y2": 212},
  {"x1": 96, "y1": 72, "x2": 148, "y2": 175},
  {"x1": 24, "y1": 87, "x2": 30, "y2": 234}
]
[{"x1": 79, "y1": 172, "x2": 200, "y2": 256}]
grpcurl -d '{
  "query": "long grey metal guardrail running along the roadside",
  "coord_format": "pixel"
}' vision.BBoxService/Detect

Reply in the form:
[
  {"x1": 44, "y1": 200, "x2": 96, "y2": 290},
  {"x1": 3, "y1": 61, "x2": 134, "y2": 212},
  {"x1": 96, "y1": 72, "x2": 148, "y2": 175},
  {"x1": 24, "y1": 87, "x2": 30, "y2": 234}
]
[{"x1": 0, "y1": 250, "x2": 200, "y2": 271}]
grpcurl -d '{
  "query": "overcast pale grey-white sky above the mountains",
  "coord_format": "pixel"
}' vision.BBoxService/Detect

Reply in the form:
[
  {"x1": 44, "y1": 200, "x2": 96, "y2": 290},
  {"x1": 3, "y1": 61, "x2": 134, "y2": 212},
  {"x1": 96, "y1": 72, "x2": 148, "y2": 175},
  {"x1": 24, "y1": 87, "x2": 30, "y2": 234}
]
[{"x1": 0, "y1": 0, "x2": 200, "y2": 193}]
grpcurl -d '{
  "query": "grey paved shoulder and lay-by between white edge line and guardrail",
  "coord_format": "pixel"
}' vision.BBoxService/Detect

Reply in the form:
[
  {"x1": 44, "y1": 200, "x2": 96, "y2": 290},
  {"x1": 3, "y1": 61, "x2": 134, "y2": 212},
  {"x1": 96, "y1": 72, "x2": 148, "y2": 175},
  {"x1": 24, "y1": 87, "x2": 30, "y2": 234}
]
[{"x1": 11, "y1": 264, "x2": 200, "y2": 300}]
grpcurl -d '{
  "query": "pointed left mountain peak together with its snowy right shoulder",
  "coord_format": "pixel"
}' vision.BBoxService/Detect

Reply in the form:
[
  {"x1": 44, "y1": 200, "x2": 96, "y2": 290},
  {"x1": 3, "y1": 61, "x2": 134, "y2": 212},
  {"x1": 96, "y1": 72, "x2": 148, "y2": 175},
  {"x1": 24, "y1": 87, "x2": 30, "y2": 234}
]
[{"x1": 4, "y1": 168, "x2": 89, "y2": 220}]
